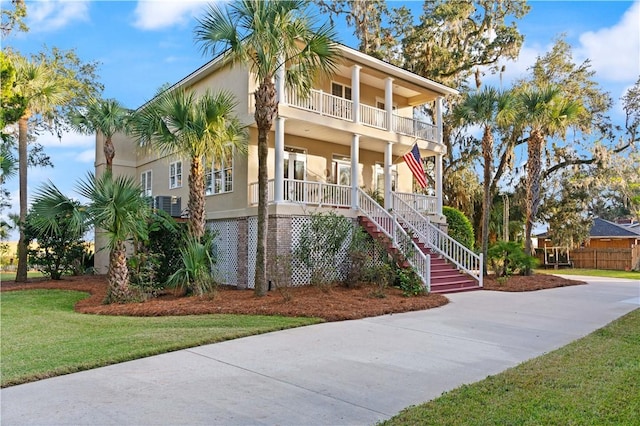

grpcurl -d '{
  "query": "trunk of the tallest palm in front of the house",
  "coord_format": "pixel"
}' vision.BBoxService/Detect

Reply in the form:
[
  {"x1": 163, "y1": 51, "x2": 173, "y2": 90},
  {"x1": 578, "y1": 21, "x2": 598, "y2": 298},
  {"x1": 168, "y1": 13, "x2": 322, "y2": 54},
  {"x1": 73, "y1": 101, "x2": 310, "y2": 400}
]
[{"x1": 255, "y1": 76, "x2": 278, "y2": 296}]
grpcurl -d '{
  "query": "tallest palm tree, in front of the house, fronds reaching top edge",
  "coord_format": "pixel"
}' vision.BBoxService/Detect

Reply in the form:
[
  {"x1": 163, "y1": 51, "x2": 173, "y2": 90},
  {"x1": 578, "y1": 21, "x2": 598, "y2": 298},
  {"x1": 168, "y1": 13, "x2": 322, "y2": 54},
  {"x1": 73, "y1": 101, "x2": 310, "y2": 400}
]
[{"x1": 195, "y1": 0, "x2": 338, "y2": 296}]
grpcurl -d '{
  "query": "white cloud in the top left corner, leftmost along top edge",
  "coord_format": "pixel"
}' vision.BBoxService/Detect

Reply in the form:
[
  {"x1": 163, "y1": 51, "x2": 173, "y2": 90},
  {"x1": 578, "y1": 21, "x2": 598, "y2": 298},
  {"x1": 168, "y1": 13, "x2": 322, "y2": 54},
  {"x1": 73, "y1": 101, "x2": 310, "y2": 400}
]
[{"x1": 27, "y1": 0, "x2": 89, "y2": 31}]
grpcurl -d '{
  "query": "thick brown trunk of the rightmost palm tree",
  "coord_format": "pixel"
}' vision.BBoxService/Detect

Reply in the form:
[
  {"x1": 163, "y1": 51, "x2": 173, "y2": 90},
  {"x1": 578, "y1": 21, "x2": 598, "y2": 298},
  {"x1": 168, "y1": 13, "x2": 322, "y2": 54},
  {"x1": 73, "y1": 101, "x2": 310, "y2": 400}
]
[{"x1": 524, "y1": 130, "x2": 544, "y2": 255}]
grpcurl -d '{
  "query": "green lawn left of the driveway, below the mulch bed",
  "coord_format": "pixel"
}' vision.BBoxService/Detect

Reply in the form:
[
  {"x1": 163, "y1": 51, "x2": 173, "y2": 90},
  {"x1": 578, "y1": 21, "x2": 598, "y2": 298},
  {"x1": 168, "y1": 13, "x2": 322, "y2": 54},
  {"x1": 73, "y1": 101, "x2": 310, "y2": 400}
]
[{"x1": 0, "y1": 290, "x2": 321, "y2": 387}]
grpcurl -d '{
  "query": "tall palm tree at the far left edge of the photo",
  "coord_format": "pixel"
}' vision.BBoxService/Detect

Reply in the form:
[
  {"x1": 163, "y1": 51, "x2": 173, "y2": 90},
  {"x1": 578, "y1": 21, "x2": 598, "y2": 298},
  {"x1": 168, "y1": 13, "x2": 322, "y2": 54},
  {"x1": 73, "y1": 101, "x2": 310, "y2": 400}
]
[{"x1": 11, "y1": 55, "x2": 68, "y2": 282}]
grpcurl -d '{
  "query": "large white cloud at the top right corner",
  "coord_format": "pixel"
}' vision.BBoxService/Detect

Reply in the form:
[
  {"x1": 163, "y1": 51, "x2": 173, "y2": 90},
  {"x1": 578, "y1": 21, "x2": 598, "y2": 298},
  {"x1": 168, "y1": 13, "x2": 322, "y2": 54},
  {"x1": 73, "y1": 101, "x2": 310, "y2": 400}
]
[{"x1": 577, "y1": 2, "x2": 640, "y2": 82}]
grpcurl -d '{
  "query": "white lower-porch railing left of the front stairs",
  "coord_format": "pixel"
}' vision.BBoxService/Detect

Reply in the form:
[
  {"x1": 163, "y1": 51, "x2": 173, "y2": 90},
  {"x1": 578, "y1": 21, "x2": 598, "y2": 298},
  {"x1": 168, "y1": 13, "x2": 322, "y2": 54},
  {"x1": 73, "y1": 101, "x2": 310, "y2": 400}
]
[{"x1": 249, "y1": 179, "x2": 351, "y2": 207}]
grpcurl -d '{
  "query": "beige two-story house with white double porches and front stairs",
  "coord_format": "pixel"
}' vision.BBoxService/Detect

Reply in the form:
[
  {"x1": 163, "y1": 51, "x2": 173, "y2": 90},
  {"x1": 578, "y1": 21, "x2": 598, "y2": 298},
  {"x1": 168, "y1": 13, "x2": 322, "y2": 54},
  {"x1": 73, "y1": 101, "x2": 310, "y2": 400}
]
[{"x1": 96, "y1": 46, "x2": 482, "y2": 288}]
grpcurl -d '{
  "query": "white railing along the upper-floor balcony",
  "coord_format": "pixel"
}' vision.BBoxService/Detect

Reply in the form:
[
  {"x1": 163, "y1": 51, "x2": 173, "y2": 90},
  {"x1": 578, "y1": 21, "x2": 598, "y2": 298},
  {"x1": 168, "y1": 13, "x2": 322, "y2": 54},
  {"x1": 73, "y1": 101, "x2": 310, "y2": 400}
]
[{"x1": 286, "y1": 88, "x2": 438, "y2": 142}]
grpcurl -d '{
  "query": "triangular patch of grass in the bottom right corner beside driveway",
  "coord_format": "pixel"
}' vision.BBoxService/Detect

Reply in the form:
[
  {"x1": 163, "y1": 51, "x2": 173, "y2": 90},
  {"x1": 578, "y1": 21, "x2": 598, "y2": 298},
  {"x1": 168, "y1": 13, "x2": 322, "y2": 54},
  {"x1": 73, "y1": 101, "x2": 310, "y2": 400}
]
[{"x1": 382, "y1": 309, "x2": 640, "y2": 426}]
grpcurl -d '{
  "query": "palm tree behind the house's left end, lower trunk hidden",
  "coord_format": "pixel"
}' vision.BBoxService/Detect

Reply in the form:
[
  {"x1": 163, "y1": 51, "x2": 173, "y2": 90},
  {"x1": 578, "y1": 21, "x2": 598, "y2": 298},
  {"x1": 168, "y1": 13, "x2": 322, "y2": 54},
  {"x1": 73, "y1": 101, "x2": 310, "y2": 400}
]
[{"x1": 71, "y1": 99, "x2": 130, "y2": 172}]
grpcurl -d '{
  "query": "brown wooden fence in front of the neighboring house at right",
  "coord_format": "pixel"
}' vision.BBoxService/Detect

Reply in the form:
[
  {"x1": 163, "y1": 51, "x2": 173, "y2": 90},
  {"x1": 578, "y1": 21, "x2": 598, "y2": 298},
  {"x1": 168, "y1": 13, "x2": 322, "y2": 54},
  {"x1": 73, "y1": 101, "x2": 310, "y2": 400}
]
[{"x1": 569, "y1": 245, "x2": 640, "y2": 271}]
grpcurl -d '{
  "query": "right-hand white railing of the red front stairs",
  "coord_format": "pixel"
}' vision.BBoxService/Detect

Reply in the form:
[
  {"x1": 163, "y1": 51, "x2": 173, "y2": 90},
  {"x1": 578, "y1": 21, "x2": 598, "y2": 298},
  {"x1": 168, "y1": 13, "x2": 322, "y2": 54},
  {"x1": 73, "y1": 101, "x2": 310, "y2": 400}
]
[{"x1": 392, "y1": 193, "x2": 483, "y2": 287}]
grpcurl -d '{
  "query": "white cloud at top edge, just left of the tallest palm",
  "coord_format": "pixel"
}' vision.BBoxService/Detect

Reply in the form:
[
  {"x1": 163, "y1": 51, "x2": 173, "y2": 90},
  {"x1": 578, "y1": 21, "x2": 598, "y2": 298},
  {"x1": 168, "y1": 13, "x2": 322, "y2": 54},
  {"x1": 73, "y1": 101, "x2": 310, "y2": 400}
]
[{"x1": 133, "y1": 0, "x2": 206, "y2": 30}]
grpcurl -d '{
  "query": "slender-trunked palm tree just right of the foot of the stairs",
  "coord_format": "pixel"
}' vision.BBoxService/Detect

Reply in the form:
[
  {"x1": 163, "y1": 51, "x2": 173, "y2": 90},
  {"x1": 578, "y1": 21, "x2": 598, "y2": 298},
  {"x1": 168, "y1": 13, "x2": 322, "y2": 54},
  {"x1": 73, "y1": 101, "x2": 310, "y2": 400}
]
[{"x1": 454, "y1": 87, "x2": 515, "y2": 275}]
